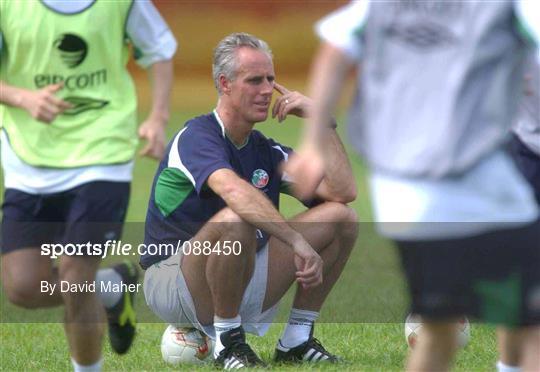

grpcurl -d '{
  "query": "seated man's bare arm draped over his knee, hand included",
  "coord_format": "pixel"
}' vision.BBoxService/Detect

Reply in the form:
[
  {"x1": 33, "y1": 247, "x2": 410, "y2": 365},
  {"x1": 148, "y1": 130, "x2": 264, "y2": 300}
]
[{"x1": 207, "y1": 169, "x2": 322, "y2": 287}]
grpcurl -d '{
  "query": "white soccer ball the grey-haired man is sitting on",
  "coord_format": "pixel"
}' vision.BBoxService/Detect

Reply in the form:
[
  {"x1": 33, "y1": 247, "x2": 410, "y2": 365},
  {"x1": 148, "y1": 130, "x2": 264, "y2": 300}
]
[{"x1": 161, "y1": 325, "x2": 213, "y2": 365}]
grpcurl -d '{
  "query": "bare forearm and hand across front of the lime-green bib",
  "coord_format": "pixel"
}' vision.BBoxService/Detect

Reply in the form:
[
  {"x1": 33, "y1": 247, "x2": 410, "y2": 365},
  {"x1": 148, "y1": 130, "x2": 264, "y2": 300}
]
[{"x1": 0, "y1": 81, "x2": 71, "y2": 124}]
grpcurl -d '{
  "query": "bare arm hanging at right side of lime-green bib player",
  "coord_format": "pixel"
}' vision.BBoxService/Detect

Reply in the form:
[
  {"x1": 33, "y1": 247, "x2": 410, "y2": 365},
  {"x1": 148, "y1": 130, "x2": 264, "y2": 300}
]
[{"x1": 139, "y1": 60, "x2": 173, "y2": 160}]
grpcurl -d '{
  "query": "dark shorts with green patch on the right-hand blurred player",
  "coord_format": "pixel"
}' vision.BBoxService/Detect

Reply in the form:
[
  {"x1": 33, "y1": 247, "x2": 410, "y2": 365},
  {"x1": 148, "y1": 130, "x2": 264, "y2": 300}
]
[{"x1": 397, "y1": 221, "x2": 540, "y2": 326}]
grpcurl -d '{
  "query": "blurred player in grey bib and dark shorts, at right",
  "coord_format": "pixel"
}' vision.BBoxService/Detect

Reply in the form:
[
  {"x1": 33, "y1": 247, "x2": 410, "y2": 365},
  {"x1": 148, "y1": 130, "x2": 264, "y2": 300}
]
[{"x1": 286, "y1": 1, "x2": 540, "y2": 371}]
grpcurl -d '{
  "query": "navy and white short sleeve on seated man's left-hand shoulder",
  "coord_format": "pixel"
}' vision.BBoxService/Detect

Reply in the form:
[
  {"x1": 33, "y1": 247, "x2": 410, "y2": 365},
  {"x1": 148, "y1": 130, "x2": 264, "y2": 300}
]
[{"x1": 168, "y1": 122, "x2": 233, "y2": 195}]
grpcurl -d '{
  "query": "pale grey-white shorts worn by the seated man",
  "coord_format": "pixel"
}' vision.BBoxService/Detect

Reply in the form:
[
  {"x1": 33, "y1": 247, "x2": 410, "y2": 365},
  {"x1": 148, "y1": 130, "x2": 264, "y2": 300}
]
[{"x1": 144, "y1": 244, "x2": 279, "y2": 339}]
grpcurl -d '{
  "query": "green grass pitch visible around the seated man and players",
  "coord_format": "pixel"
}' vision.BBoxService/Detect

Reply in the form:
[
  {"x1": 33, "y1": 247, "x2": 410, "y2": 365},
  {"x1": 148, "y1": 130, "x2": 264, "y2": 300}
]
[{"x1": 0, "y1": 113, "x2": 496, "y2": 371}]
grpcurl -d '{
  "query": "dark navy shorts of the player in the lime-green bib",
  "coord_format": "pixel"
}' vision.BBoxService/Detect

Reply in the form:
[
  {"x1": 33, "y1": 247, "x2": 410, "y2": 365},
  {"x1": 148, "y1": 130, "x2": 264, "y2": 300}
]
[{"x1": 0, "y1": 181, "x2": 130, "y2": 254}]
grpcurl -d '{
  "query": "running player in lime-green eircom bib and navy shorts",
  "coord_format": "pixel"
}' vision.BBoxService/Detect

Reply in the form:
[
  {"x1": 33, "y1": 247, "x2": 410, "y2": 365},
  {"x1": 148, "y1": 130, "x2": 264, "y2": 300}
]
[{"x1": 0, "y1": 0, "x2": 176, "y2": 371}]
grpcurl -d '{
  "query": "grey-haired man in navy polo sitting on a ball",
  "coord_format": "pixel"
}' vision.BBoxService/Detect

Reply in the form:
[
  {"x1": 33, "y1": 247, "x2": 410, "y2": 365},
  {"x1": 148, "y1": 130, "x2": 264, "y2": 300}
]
[{"x1": 141, "y1": 34, "x2": 357, "y2": 369}]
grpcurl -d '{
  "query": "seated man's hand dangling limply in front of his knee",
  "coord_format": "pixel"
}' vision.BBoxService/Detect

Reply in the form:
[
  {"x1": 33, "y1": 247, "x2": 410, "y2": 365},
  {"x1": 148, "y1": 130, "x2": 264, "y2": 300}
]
[{"x1": 293, "y1": 235, "x2": 323, "y2": 288}]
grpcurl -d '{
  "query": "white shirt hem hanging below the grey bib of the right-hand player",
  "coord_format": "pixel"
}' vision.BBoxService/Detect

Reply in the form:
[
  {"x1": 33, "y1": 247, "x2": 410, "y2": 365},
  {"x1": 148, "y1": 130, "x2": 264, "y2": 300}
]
[{"x1": 370, "y1": 150, "x2": 538, "y2": 241}]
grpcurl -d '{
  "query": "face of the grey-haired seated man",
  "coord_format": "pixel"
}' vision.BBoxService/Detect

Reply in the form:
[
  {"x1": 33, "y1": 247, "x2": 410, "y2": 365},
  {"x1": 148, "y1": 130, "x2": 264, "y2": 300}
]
[{"x1": 228, "y1": 47, "x2": 274, "y2": 124}]
